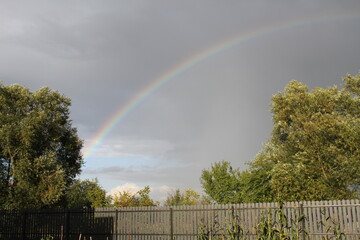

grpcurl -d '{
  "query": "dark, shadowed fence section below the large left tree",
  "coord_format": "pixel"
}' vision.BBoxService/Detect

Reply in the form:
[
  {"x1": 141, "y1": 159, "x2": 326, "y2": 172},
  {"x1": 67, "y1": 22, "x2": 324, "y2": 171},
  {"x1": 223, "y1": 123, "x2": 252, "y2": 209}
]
[{"x1": 0, "y1": 209, "x2": 114, "y2": 240}]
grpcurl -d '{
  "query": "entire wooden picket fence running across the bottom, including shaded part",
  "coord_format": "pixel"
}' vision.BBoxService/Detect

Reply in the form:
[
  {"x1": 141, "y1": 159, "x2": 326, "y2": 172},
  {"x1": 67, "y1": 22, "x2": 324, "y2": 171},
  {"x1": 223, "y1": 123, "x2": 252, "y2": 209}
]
[{"x1": 0, "y1": 200, "x2": 360, "y2": 240}]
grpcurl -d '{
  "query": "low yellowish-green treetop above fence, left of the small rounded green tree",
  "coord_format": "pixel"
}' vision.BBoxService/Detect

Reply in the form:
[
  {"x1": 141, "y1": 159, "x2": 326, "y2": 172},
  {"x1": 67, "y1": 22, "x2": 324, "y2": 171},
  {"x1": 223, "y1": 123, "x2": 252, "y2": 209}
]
[{"x1": 165, "y1": 189, "x2": 207, "y2": 206}]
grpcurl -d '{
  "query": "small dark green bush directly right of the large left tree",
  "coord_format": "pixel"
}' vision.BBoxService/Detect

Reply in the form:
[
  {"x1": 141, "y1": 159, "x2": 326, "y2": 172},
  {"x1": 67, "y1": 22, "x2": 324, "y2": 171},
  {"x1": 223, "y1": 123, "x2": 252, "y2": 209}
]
[{"x1": 65, "y1": 179, "x2": 111, "y2": 208}]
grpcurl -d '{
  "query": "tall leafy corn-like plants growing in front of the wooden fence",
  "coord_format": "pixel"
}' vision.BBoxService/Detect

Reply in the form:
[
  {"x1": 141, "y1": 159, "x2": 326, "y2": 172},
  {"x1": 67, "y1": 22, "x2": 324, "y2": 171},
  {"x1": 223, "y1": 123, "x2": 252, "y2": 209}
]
[{"x1": 197, "y1": 203, "x2": 345, "y2": 240}]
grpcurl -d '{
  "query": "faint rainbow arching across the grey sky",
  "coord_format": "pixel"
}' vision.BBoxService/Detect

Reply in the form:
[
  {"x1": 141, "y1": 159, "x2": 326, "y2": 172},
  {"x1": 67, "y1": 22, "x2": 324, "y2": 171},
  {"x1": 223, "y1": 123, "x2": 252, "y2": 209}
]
[{"x1": 83, "y1": 12, "x2": 360, "y2": 159}]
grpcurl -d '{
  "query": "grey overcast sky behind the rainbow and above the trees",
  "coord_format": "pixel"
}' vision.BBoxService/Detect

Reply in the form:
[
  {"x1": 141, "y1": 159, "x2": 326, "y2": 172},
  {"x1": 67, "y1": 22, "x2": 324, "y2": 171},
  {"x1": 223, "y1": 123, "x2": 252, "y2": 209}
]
[{"x1": 0, "y1": 0, "x2": 360, "y2": 202}]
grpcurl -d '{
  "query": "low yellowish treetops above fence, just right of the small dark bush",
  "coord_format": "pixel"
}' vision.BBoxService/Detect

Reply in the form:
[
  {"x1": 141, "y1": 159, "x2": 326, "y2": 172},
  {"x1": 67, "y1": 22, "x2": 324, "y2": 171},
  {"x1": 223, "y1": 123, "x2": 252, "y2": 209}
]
[{"x1": 113, "y1": 186, "x2": 159, "y2": 207}]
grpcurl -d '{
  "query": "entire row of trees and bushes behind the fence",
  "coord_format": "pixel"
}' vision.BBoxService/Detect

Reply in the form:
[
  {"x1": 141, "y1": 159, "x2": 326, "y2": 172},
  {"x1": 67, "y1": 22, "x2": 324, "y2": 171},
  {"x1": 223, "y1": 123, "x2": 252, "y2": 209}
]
[{"x1": 0, "y1": 75, "x2": 360, "y2": 209}]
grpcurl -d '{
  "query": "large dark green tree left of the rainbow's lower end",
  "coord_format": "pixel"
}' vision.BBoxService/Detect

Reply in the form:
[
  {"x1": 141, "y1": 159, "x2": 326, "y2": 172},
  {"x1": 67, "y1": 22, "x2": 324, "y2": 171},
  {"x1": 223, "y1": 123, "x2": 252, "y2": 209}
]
[{"x1": 0, "y1": 84, "x2": 83, "y2": 209}]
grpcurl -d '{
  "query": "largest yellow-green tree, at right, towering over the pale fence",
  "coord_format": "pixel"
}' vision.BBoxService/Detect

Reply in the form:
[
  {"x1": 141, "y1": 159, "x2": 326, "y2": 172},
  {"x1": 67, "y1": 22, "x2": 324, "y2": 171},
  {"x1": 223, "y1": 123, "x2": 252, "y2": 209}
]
[{"x1": 249, "y1": 75, "x2": 360, "y2": 201}]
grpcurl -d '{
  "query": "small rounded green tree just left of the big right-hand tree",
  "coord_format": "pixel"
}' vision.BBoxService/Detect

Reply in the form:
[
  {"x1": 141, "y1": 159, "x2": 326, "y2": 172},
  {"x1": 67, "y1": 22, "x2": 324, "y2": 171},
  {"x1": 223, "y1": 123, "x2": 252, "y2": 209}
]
[{"x1": 200, "y1": 161, "x2": 242, "y2": 204}]
